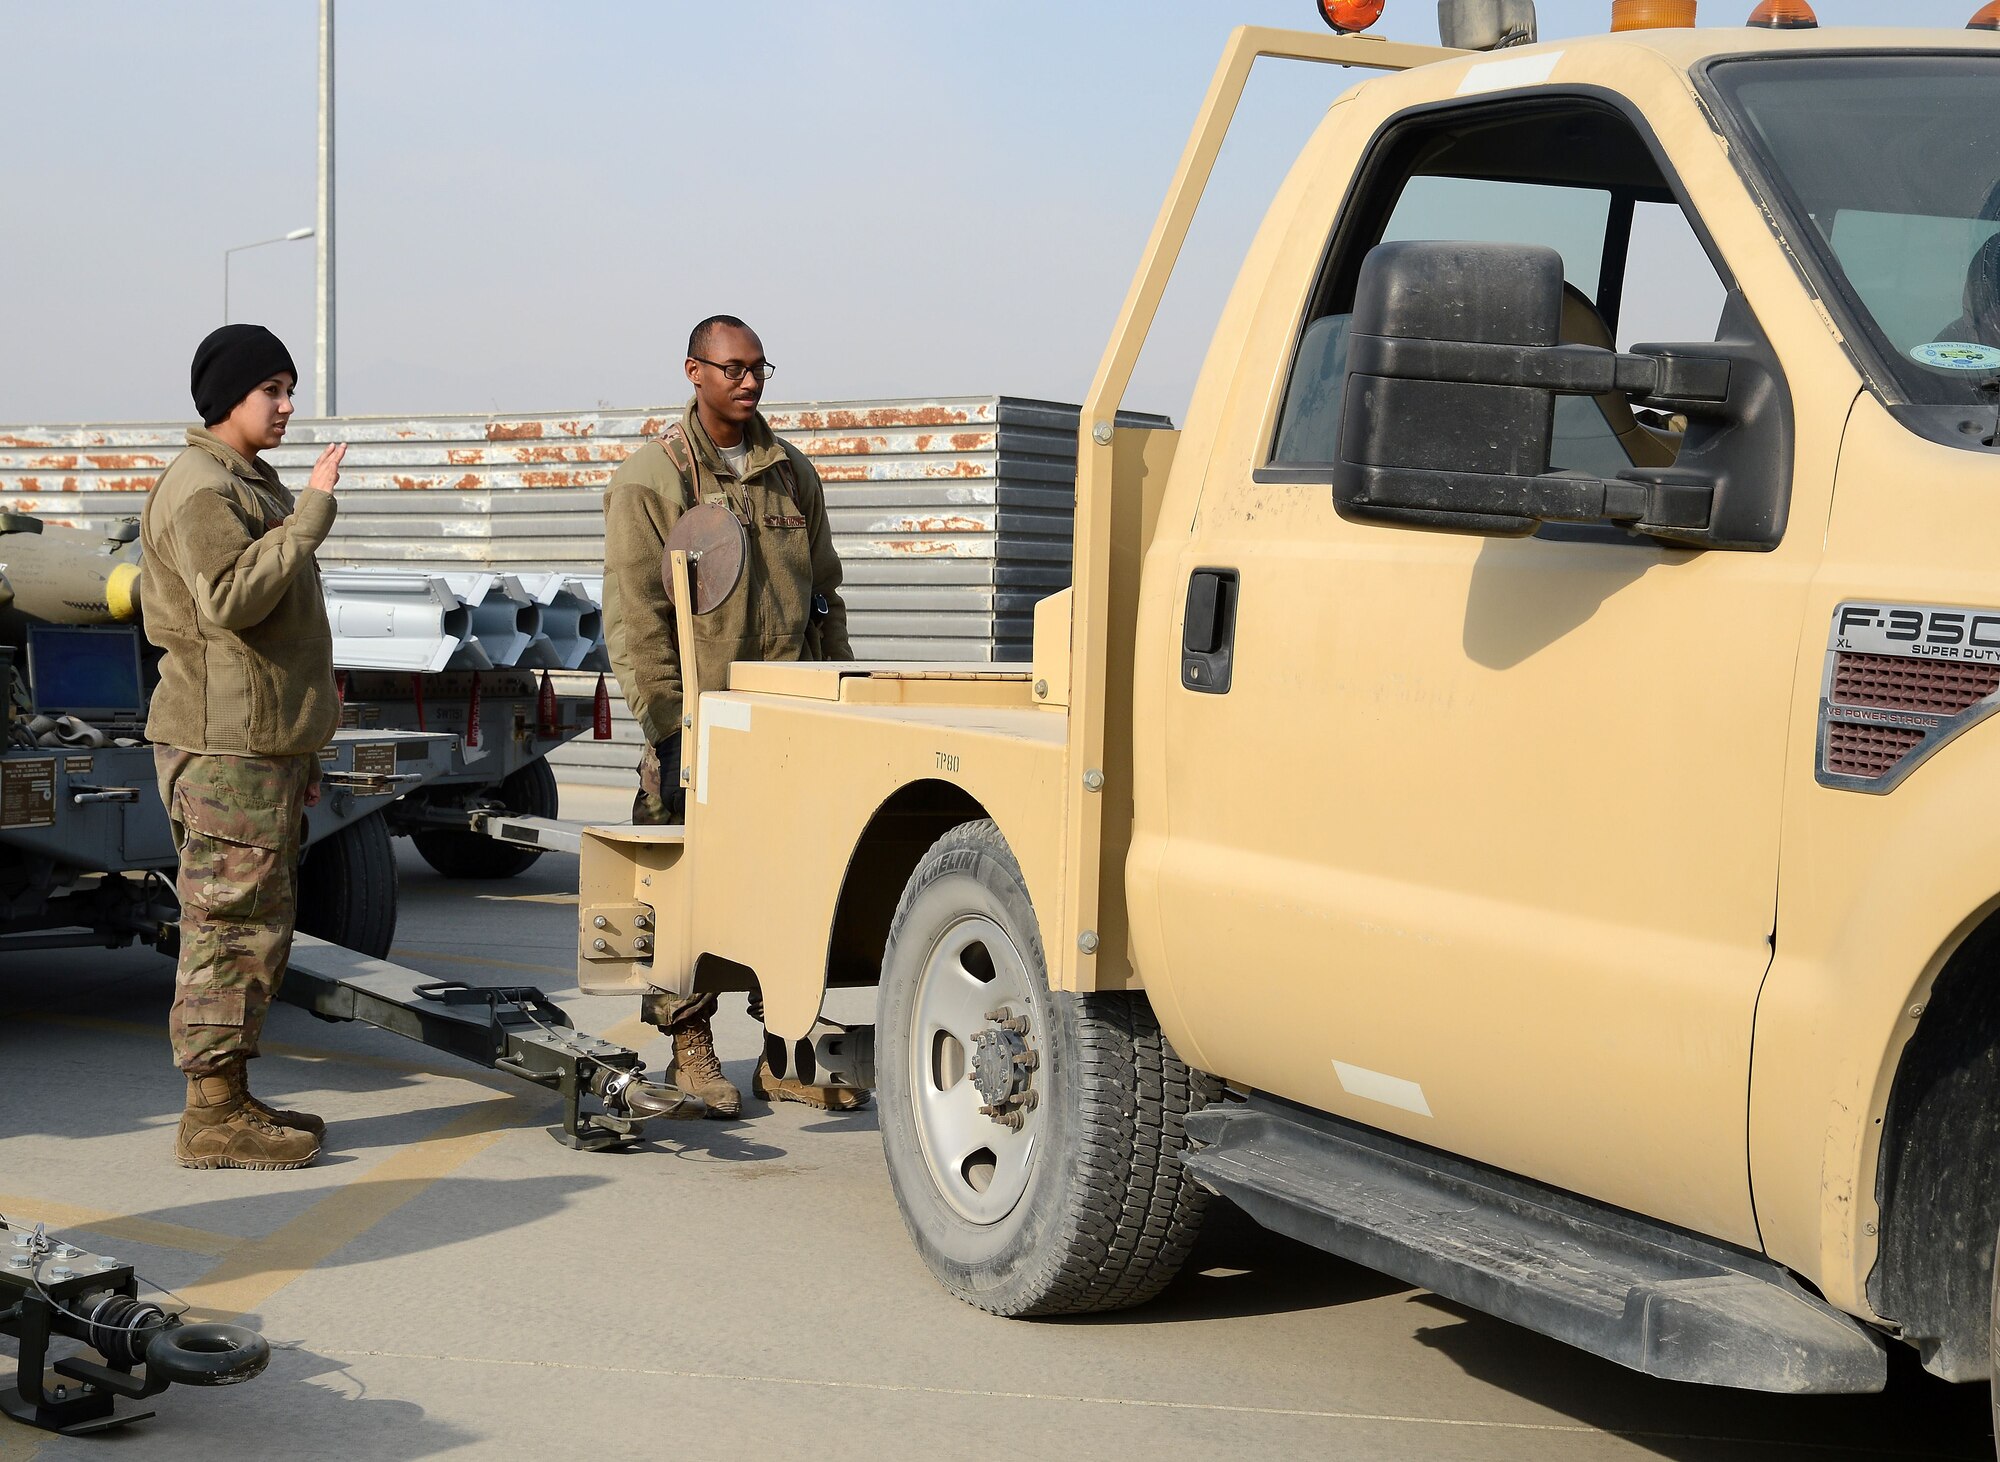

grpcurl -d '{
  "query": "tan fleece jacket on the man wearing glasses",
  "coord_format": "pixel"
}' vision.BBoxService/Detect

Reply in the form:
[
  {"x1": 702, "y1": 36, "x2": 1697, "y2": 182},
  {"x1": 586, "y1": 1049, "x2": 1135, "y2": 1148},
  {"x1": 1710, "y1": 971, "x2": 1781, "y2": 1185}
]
[{"x1": 604, "y1": 400, "x2": 854, "y2": 746}]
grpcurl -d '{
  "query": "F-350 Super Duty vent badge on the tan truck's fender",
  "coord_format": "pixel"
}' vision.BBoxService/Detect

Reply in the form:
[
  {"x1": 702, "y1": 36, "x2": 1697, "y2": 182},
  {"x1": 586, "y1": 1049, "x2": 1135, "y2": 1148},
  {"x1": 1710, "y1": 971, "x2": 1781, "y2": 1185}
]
[{"x1": 1816, "y1": 600, "x2": 2000, "y2": 792}]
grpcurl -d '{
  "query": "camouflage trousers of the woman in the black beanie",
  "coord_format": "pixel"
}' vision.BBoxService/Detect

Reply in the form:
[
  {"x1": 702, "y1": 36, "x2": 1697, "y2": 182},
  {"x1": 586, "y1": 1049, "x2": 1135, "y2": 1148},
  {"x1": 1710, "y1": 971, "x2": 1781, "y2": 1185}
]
[{"x1": 154, "y1": 746, "x2": 316, "y2": 1076}]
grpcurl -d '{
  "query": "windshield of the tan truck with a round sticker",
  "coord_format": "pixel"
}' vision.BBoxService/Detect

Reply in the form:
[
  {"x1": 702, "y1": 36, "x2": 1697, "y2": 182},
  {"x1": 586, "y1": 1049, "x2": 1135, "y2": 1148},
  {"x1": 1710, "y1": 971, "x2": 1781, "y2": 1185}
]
[{"x1": 1708, "y1": 54, "x2": 2000, "y2": 406}]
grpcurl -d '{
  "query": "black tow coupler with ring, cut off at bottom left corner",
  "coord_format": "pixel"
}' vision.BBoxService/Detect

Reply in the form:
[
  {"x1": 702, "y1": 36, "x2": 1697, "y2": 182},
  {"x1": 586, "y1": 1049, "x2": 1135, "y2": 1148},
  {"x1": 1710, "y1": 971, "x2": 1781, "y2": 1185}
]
[{"x1": 0, "y1": 1220, "x2": 270, "y2": 1450}]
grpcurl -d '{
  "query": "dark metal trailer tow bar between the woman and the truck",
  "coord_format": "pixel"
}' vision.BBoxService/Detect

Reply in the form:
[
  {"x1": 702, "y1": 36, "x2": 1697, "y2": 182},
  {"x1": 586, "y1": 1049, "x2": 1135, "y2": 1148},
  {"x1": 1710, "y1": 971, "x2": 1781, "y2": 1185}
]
[{"x1": 278, "y1": 934, "x2": 704, "y2": 1152}]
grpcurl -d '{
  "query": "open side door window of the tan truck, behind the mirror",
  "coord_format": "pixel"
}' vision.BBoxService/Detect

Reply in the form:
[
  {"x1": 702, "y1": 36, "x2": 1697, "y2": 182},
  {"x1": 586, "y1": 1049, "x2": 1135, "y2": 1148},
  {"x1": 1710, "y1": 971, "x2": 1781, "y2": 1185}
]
[{"x1": 1270, "y1": 100, "x2": 1724, "y2": 476}]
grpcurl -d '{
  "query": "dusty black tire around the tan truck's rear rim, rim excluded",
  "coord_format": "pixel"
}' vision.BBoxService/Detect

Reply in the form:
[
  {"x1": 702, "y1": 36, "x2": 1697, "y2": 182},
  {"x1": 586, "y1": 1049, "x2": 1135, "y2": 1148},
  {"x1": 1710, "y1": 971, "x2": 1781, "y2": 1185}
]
[{"x1": 876, "y1": 822, "x2": 1216, "y2": 1316}]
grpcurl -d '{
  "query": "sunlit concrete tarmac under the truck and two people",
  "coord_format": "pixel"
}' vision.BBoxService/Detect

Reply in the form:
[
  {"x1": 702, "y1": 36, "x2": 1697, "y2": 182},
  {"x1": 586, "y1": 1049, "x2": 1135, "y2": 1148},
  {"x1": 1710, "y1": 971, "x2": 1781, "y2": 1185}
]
[{"x1": 0, "y1": 788, "x2": 1992, "y2": 1462}]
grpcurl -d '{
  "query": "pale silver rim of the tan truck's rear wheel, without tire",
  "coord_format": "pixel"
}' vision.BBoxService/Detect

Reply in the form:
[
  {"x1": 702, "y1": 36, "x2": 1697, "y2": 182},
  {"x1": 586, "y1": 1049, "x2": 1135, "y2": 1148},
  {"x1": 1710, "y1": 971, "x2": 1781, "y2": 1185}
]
[{"x1": 906, "y1": 914, "x2": 1042, "y2": 1224}]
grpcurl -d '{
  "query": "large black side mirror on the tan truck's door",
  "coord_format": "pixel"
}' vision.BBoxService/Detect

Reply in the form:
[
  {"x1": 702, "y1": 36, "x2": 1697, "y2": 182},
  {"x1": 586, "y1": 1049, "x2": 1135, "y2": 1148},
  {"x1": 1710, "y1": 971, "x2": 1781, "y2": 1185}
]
[{"x1": 1332, "y1": 242, "x2": 1792, "y2": 548}]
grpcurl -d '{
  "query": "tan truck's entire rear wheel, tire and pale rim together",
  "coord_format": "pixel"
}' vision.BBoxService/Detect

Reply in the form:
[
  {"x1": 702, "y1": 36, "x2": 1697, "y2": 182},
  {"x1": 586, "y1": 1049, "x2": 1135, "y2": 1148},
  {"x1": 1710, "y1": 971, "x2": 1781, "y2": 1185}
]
[{"x1": 876, "y1": 822, "x2": 1216, "y2": 1316}]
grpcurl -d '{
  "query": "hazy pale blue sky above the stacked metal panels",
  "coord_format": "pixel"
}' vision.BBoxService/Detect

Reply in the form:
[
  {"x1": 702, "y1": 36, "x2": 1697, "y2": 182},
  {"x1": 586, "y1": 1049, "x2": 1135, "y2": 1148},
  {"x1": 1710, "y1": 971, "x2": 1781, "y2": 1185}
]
[{"x1": 0, "y1": 0, "x2": 1976, "y2": 422}]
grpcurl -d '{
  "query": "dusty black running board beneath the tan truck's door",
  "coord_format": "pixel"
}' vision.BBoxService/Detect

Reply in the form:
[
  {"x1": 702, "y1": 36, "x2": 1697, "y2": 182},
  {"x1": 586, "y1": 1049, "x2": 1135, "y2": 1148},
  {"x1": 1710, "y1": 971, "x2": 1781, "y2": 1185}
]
[{"x1": 1186, "y1": 1096, "x2": 1888, "y2": 1392}]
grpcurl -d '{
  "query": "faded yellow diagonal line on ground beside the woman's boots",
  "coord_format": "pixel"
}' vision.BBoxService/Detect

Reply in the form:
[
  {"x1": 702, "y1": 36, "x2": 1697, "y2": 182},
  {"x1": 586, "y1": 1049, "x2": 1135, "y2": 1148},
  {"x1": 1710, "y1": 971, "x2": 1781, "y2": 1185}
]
[{"x1": 178, "y1": 1098, "x2": 534, "y2": 1320}]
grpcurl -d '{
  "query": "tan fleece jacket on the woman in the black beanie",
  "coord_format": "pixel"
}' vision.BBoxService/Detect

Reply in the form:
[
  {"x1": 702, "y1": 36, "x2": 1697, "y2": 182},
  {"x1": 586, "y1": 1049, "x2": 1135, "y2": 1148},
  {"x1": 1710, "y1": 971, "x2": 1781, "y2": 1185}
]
[{"x1": 140, "y1": 426, "x2": 340, "y2": 756}]
